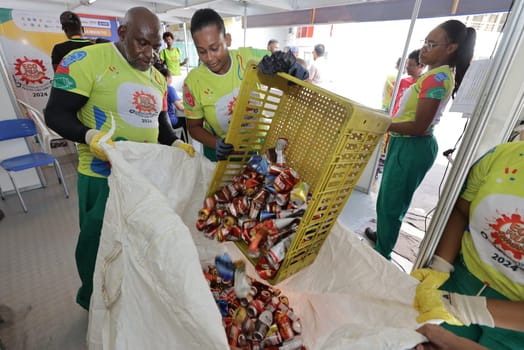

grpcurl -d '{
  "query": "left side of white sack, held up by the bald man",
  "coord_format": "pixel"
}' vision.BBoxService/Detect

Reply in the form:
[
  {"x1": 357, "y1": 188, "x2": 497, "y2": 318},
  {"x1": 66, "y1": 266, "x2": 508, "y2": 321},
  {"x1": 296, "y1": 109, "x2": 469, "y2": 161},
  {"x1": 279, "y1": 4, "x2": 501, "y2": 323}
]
[{"x1": 88, "y1": 142, "x2": 229, "y2": 350}]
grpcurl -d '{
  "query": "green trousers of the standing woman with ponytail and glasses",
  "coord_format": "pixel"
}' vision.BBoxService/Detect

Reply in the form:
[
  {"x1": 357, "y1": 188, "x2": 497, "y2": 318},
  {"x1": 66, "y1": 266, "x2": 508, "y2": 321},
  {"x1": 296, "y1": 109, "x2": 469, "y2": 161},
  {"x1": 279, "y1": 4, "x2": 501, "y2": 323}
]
[{"x1": 375, "y1": 135, "x2": 438, "y2": 259}]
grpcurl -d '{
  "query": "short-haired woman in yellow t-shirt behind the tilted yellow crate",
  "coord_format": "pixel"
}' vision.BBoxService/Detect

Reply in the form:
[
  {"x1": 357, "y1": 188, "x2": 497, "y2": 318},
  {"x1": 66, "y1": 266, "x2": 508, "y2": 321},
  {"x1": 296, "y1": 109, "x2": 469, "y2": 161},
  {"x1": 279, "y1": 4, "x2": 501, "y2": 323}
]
[{"x1": 183, "y1": 8, "x2": 269, "y2": 161}]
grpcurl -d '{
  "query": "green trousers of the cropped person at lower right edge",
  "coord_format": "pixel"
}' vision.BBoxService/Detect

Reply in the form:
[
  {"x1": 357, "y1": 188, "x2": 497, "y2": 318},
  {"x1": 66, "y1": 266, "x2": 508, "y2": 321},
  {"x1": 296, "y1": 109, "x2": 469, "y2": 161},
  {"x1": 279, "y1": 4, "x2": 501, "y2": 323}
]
[{"x1": 440, "y1": 256, "x2": 524, "y2": 350}]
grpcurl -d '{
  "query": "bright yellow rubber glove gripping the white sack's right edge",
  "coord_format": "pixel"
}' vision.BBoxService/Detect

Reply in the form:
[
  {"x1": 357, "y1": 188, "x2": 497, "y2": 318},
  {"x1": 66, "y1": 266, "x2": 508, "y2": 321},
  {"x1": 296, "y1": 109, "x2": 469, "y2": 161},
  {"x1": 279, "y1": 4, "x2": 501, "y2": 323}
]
[{"x1": 411, "y1": 269, "x2": 463, "y2": 326}]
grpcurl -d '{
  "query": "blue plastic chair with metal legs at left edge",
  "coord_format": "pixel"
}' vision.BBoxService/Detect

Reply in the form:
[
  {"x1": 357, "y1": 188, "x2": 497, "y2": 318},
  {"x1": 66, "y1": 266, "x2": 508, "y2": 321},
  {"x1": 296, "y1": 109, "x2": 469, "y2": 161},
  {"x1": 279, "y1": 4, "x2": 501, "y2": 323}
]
[{"x1": 0, "y1": 119, "x2": 69, "y2": 213}]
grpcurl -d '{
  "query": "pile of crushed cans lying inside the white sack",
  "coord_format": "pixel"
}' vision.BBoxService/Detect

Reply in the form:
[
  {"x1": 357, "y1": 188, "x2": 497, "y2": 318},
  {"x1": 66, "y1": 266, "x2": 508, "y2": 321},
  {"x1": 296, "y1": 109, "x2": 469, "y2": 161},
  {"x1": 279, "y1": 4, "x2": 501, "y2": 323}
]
[{"x1": 204, "y1": 256, "x2": 306, "y2": 350}]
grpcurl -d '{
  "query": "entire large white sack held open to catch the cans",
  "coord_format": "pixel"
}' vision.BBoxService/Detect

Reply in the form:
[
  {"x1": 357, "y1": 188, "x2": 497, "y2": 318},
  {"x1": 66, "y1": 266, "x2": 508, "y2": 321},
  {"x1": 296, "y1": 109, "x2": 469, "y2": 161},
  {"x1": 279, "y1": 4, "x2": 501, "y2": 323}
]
[{"x1": 88, "y1": 142, "x2": 430, "y2": 350}]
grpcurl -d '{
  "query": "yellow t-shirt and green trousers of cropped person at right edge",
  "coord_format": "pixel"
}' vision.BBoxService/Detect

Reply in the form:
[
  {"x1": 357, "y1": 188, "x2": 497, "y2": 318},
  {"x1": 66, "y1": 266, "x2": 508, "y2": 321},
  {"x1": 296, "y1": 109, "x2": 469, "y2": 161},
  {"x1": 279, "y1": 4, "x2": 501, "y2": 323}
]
[{"x1": 441, "y1": 142, "x2": 524, "y2": 349}]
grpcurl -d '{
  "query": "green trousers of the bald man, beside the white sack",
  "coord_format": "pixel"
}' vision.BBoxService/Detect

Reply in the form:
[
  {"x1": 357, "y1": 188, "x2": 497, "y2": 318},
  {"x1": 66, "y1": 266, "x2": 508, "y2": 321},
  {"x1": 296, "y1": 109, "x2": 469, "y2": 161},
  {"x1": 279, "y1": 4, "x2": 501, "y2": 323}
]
[{"x1": 75, "y1": 174, "x2": 109, "y2": 310}]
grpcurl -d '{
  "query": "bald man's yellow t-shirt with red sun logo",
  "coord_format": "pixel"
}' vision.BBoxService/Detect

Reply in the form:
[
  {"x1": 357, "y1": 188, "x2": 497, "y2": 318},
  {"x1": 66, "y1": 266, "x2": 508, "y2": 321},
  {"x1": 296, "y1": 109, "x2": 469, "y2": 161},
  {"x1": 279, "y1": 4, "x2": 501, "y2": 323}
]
[{"x1": 53, "y1": 43, "x2": 167, "y2": 177}]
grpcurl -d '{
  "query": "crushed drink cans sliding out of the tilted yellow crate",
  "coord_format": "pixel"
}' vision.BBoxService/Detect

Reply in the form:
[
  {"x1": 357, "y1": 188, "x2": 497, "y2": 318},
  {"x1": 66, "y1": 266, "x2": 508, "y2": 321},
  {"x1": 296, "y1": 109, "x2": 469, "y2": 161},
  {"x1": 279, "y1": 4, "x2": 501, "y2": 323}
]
[{"x1": 196, "y1": 138, "x2": 310, "y2": 279}]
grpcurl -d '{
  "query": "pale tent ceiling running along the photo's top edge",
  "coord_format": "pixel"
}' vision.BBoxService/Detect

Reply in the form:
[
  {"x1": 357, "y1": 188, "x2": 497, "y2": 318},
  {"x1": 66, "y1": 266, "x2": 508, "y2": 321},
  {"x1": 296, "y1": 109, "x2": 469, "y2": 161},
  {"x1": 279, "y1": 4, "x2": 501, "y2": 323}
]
[{"x1": 0, "y1": 0, "x2": 511, "y2": 27}]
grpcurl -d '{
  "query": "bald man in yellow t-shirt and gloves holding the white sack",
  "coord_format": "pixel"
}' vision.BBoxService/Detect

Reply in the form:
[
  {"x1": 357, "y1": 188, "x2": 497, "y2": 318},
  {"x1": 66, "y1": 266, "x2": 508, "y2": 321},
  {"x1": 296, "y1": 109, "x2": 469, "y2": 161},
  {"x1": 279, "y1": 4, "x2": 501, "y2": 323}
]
[{"x1": 44, "y1": 7, "x2": 194, "y2": 309}]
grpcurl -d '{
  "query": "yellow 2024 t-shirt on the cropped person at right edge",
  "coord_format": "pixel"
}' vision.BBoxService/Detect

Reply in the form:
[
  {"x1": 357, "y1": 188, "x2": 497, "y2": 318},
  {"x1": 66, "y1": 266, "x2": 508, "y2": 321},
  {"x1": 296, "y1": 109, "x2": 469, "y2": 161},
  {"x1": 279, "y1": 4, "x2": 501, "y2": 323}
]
[{"x1": 461, "y1": 142, "x2": 524, "y2": 301}]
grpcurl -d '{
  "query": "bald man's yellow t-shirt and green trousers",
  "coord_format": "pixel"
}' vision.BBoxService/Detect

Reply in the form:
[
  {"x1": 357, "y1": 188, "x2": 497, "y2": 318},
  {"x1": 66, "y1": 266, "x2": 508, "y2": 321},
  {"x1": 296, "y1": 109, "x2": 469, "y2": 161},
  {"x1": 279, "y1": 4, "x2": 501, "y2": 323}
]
[{"x1": 53, "y1": 43, "x2": 166, "y2": 309}]
